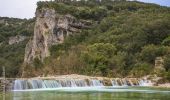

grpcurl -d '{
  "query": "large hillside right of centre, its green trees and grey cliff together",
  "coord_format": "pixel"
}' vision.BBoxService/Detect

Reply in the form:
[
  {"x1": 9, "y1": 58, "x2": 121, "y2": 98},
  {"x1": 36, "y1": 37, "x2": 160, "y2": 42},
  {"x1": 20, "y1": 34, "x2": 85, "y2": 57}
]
[{"x1": 1, "y1": 0, "x2": 170, "y2": 79}]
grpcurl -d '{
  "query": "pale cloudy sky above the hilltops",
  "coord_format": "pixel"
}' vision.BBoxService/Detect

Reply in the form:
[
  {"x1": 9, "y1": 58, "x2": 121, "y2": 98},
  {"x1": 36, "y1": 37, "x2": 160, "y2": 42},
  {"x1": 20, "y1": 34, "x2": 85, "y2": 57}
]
[{"x1": 0, "y1": 0, "x2": 170, "y2": 18}]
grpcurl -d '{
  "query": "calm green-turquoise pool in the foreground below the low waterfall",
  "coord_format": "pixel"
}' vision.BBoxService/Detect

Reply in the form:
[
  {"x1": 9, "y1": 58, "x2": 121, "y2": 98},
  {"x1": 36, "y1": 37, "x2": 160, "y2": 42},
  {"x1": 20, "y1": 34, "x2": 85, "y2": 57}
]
[{"x1": 0, "y1": 87, "x2": 170, "y2": 100}]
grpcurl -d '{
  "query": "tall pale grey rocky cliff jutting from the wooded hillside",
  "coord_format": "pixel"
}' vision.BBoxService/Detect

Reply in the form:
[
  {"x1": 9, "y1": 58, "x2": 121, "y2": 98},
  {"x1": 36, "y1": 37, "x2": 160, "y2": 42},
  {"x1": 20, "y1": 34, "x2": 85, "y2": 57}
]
[{"x1": 24, "y1": 8, "x2": 88, "y2": 64}]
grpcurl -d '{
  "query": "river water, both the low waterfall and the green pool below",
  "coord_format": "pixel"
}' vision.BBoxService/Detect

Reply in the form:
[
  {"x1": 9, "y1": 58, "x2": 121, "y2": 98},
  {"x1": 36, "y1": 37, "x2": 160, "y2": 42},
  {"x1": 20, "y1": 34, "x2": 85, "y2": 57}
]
[{"x1": 0, "y1": 79, "x2": 170, "y2": 100}]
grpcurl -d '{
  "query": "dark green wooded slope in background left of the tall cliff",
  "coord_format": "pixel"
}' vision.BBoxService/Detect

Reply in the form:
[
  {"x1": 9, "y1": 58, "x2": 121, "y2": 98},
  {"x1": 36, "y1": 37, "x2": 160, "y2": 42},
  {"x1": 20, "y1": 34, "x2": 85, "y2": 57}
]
[{"x1": 0, "y1": 17, "x2": 34, "y2": 77}]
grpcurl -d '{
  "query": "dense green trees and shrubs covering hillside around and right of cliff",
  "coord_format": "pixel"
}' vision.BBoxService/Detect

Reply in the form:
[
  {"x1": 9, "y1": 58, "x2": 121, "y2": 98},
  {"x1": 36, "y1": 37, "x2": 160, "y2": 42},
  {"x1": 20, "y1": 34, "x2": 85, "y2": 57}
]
[{"x1": 0, "y1": 0, "x2": 170, "y2": 80}]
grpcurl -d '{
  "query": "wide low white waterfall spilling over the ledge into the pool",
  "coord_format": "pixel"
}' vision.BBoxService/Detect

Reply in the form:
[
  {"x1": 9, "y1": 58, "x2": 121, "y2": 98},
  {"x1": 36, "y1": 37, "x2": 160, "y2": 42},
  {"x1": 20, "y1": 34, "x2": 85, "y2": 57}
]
[{"x1": 13, "y1": 78, "x2": 153, "y2": 90}]
